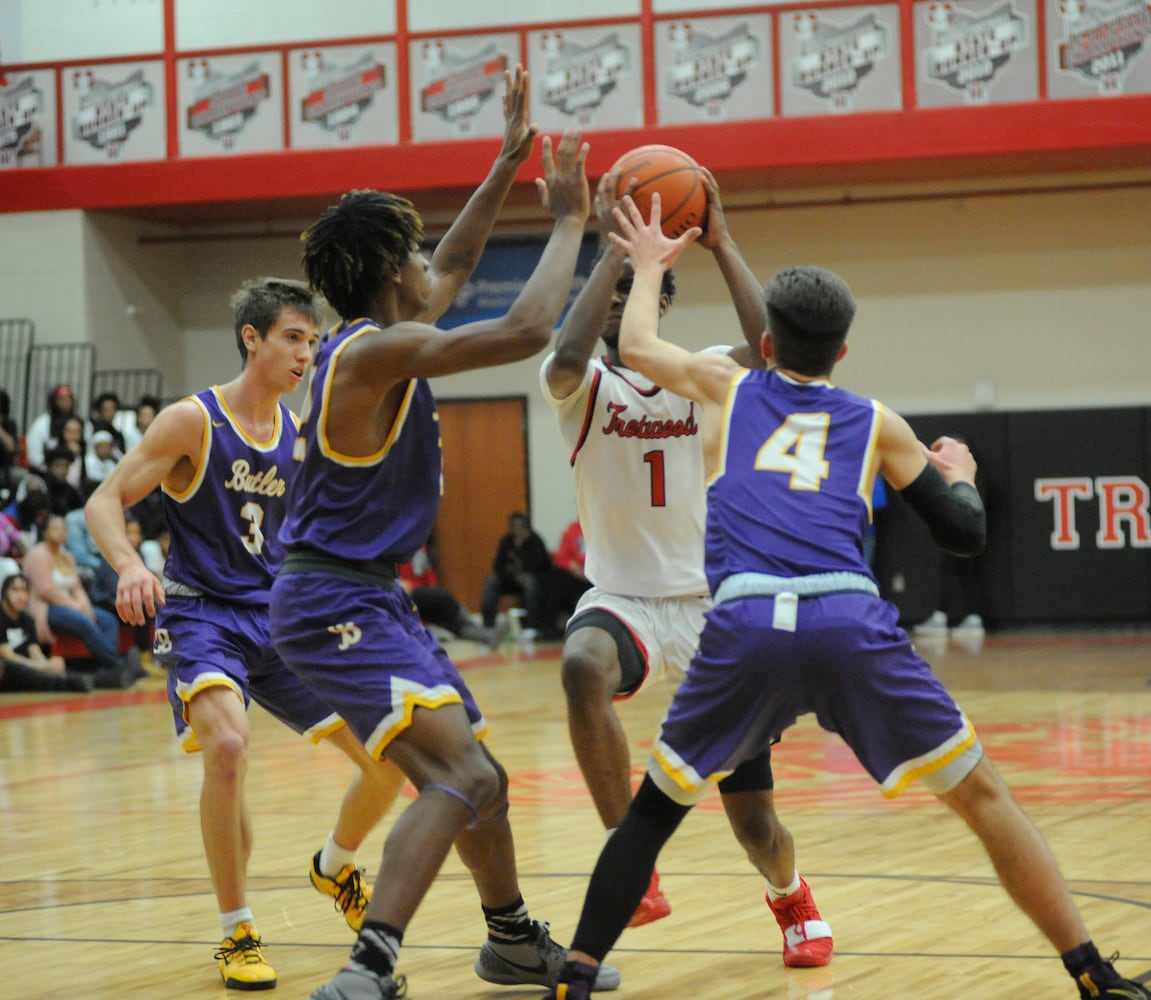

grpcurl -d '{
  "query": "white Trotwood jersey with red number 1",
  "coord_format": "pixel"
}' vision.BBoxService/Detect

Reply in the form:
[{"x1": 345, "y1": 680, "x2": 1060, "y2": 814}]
[{"x1": 540, "y1": 354, "x2": 708, "y2": 597}]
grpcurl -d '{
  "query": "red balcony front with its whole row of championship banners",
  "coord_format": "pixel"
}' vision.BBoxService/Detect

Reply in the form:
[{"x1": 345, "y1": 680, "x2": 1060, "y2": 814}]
[{"x1": 0, "y1": 0, "x2": 1151, "y2": 212}]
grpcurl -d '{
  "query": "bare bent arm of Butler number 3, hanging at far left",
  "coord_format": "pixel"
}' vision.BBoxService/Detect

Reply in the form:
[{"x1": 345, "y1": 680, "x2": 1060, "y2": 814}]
[{"x1": 84, "y1": 400, "x2": 205, "y2": 625}]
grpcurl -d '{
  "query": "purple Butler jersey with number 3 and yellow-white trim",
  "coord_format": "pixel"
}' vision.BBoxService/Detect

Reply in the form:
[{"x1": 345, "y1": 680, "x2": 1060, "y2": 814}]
[{"x1": 162, "y1": 387, "x2": 296, "y2": 608}]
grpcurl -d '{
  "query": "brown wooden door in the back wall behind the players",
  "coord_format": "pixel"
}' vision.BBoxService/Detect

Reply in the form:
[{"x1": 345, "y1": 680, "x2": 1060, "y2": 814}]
[{"x1": 435, "y1": 396, "x2": 529, "y2": 611}]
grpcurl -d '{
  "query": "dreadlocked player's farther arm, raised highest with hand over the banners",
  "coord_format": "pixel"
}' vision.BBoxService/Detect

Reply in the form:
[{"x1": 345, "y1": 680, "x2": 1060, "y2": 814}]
[{"x1": 419, "y1": 66, "x2": 540, "y2": 323}]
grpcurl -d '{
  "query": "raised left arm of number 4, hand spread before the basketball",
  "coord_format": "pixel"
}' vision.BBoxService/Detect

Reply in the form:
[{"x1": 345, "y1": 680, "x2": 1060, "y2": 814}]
[{"x1": 611, "y1": 193, "x2": 739, "y2": 404}]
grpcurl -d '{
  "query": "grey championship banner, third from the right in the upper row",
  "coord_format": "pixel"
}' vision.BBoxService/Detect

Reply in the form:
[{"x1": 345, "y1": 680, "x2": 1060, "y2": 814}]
[{"x1": 779, "y1": 5, "x2": 904, "y2": 116}]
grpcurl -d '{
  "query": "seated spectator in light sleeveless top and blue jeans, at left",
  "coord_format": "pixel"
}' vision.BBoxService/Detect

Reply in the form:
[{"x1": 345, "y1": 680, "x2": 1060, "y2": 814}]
[{"x1": 24, "y1": 514, "x2": 146, "y2": 687}]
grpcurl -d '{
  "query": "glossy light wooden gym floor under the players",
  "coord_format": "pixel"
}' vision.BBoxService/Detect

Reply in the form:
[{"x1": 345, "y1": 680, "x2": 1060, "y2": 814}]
[{"x1": 0, "y1": 631, "x2": 1151, "y2": 1000}]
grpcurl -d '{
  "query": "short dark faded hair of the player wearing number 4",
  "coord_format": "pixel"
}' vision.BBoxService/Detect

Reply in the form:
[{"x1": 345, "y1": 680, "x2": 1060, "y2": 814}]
[{"x1": 765, "y1": 267, "x2": 855, "y2": 375}]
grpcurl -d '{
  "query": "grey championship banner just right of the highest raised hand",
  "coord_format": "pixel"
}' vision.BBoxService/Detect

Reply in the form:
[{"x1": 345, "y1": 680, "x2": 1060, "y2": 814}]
[{"x1": 527, "y1": 24, "x2": 643, "y2": 133}]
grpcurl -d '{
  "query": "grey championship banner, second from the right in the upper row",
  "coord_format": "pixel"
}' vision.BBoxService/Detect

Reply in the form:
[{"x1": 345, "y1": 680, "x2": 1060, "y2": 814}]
[{"x1": 913, "y1": 0, "x2": 1039, "y2": 108}]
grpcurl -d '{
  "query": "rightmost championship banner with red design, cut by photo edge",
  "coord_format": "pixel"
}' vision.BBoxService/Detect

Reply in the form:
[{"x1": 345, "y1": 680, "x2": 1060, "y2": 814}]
[{"x1": 1047, "y1": 0, "x2": 1151, "y2": 98}]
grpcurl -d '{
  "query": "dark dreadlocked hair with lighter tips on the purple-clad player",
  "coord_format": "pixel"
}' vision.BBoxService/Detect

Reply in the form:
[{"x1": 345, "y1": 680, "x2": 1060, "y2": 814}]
[{"x1": 300, "y1": 191, "x2": 424, "y2": 320}]
